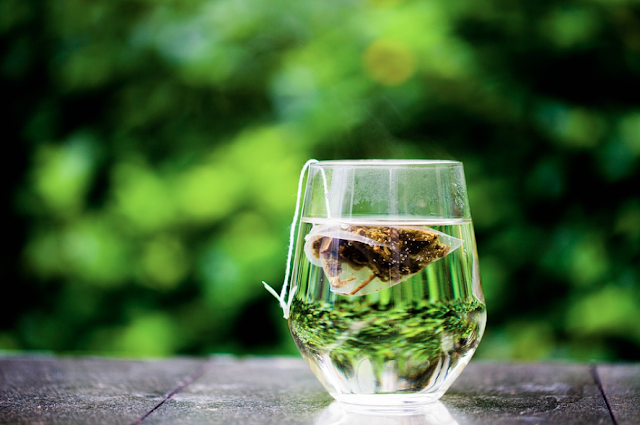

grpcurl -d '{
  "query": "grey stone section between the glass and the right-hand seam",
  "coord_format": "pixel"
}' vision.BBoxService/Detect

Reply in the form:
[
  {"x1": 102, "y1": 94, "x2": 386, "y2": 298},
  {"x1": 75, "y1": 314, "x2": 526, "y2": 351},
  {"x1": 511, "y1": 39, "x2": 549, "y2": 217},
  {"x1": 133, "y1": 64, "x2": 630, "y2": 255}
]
[{"x1": 442, "y1": 362, "x2": 612, "y2": 425}]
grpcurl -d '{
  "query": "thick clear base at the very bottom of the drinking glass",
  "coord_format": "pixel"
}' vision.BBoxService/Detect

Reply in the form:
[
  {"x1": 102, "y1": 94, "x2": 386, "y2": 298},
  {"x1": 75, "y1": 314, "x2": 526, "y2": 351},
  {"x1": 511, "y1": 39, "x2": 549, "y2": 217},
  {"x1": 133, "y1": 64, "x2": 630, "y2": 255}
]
[{"x1": 332, "y1": 391, "x2": 444, "y2": 415}]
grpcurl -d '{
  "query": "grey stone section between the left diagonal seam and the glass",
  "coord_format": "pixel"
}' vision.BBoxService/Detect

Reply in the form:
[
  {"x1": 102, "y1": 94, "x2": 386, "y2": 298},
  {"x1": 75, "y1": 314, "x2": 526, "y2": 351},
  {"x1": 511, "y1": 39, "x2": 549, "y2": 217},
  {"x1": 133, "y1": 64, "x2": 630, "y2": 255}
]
[{"x1": 144, "y1": 357, "x2": 333, "y2": 425}]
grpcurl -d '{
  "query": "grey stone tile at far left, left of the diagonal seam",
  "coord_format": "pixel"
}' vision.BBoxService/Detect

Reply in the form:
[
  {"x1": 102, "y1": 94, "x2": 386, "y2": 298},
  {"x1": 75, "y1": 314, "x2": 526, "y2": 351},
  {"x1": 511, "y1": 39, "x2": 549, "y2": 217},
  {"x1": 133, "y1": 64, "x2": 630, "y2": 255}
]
[{"x1": 0, "y1": 356, "x2": 202, "y2": 425}]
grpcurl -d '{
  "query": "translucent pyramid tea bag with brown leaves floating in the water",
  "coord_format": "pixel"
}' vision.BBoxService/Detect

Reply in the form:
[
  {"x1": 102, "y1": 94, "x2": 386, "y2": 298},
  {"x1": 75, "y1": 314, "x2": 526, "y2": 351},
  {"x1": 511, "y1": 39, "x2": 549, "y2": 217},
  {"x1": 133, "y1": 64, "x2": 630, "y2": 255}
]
[{"x1": 304, "y1": 222, "x2": 462, "y2": 295}]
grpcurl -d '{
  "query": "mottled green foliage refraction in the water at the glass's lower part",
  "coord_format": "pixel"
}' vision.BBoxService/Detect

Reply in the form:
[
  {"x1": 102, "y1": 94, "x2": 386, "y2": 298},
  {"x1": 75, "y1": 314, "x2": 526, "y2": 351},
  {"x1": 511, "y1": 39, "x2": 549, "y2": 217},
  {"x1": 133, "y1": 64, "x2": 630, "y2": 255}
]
[{"x1": 290, "y1": 300, "x2": 484, "y2": 392}]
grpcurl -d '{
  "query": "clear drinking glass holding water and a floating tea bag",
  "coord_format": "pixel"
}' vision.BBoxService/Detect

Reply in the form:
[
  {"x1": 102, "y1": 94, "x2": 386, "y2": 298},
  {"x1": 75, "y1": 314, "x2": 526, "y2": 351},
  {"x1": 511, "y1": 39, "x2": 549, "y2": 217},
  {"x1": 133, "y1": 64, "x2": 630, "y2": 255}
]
[{"x1": 288, "y1": 160, "x2": 486, "y2": 414}]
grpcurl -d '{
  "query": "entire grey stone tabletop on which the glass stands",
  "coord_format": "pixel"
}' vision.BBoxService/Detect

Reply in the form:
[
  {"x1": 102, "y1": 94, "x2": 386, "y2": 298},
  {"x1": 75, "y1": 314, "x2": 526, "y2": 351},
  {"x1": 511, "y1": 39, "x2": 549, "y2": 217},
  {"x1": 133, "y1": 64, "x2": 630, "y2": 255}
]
[{"x1": 0, "y1": 356, "x2": 640, "y2": 425}]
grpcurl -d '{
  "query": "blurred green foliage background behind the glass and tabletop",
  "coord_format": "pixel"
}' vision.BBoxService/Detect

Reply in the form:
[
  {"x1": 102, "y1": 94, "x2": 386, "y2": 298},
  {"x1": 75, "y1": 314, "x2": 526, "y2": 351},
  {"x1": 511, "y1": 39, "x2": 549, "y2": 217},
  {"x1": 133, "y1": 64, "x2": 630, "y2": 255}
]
[{"x1": 0, "y1": 0, "x2": 640, "y2": 360}]
